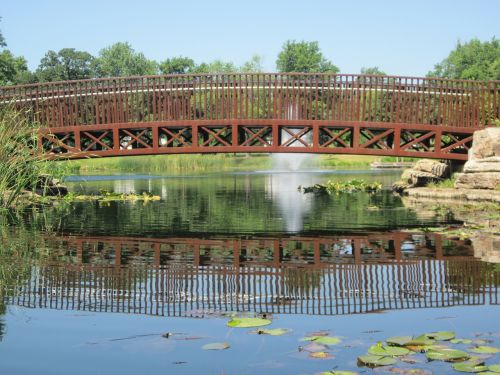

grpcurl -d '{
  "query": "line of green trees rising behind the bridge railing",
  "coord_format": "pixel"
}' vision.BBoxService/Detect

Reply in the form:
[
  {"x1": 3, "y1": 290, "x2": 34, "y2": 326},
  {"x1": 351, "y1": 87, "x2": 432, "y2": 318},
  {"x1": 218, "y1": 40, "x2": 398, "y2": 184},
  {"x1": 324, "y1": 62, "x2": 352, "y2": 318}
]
[{"x1": 0, "y1": 16, "x2": 500, "y2": 86}]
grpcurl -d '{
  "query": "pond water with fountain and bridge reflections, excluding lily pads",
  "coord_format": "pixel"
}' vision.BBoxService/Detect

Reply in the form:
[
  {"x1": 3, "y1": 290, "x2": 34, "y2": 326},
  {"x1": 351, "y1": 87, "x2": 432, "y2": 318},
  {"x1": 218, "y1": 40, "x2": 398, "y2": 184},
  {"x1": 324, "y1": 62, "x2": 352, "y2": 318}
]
[{"x1": 0, "y1": 171, "x2": 499, "y2": 374}]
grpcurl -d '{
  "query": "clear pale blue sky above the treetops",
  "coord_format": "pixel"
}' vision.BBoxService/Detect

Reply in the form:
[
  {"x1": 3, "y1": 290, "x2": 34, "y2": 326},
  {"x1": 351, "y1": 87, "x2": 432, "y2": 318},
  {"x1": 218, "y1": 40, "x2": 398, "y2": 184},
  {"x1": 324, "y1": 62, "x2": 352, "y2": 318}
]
[{"x1": 0, "y1": 0, "x2": 500, "y2": 76}]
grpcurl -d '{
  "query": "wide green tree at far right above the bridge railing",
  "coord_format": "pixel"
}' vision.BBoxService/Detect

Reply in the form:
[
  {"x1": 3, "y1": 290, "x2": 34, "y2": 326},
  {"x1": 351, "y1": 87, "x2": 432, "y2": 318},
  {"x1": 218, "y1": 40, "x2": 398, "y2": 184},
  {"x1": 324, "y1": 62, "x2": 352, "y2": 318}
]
[{"x1": 427, "y1": 38, "x2": 500, "y2": 80}]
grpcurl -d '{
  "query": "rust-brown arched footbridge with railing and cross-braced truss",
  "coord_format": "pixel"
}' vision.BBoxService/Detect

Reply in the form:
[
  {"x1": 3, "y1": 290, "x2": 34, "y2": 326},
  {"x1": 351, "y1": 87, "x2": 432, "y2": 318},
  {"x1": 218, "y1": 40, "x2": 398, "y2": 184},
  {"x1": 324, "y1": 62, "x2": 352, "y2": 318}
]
[{"x1": 0, "y1": 73, "x2": 500, "y2": 160}]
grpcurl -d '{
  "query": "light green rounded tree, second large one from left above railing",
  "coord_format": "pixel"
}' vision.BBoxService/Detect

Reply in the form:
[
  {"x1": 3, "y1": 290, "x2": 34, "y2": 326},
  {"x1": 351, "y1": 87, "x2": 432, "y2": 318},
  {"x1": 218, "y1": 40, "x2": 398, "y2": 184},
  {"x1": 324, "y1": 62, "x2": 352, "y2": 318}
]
[{"x1": 95, "y1": 43, "x2": 158, "y2": 77}]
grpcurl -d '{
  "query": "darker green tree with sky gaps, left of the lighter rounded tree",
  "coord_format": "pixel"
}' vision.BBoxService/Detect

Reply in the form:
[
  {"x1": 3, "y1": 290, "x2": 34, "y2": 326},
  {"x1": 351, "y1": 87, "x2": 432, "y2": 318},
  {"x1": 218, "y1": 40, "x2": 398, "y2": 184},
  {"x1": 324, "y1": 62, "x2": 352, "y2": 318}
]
[{"x1": 36, "y1": 48, "x2": 95, "y2": 82}]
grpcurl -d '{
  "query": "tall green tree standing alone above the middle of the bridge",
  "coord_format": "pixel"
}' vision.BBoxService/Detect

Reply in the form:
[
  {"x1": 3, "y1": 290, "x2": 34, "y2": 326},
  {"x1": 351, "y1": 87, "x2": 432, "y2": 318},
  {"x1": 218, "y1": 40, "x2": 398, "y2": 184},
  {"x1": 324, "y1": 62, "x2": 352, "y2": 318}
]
[{"x1": 276, "y1": 40, "x2": 339, "y2": 73}]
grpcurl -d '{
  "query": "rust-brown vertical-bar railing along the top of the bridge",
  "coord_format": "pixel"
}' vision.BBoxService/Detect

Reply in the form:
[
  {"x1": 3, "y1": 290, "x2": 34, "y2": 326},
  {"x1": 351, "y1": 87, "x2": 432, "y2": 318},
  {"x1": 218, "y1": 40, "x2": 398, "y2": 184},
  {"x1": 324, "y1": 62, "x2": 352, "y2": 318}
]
[{"x1": 0, "y1": 73, "x2": 500, "y2": 128}]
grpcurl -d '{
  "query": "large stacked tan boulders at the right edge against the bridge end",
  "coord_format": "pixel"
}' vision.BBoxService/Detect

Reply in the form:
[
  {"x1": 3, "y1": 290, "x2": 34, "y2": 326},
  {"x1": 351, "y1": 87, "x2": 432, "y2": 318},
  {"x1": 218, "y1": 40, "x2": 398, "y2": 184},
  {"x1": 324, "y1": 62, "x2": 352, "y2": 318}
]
[{"x1": 455, "y1": 128, "x2": 500, "y2": 190}]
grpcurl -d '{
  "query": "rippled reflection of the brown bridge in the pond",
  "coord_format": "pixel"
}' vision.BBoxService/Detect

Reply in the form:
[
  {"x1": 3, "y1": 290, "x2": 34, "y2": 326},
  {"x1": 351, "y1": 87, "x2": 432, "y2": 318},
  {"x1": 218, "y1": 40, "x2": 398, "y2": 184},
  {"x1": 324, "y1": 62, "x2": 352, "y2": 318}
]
[{"x1": 10, "y1": 233, "x2": 500, "y2": 317}]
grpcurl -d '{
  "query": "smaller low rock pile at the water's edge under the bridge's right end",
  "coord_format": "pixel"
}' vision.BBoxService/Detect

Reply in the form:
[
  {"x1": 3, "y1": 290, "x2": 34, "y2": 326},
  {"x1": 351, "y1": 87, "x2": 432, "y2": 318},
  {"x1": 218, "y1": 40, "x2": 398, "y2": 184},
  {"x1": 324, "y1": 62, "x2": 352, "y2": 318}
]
[{"x1": 392, "y1": 159, "x2": 449, "y2": 193}]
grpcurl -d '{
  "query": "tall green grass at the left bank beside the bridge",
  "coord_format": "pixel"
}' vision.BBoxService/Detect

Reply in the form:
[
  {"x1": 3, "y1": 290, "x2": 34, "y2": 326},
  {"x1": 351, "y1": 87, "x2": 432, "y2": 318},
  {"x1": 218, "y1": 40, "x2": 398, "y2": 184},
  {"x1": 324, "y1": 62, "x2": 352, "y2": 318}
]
[{"x1": 0, "y1": 106, "x2": 47, "y2": 208}]
